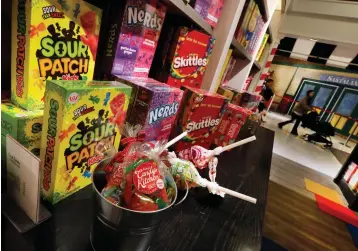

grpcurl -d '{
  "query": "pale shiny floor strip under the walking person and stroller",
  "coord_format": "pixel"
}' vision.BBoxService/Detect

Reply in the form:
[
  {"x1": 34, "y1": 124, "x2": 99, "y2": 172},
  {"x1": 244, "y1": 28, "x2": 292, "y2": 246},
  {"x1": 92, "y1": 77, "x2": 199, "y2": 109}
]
[{"x1": 262, "y1": 112, "x2": 351, "y2": 177}]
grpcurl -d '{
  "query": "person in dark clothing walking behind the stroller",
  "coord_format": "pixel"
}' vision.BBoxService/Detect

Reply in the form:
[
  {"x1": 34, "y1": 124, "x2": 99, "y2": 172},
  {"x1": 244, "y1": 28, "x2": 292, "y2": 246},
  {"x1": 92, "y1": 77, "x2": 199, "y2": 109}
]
[{"x1": 278, "y1": 90, "x2": 314, "y2": 136}]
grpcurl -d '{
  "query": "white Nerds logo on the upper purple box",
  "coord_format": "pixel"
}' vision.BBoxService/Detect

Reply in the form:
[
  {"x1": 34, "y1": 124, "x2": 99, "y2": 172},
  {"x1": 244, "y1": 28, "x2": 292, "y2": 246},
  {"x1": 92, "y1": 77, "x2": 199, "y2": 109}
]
[{"x1": 127, "y1": 6, "x2": 163, "y2": 31}]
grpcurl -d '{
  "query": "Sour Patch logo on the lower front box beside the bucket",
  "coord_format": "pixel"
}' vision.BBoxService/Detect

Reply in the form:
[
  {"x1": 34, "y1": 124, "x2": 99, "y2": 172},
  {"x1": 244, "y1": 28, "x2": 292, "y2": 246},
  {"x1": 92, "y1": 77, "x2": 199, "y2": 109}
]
[{"x1": 65, "y1": 110, "x2": 116, "y2": 172}]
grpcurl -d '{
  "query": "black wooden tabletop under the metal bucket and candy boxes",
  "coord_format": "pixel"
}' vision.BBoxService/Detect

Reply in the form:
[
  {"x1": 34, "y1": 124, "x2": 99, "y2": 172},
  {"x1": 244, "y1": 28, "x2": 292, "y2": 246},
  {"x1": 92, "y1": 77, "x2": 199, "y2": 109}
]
[{"x1": 2, "y1": 128, "x2": 274, "y2": 251}]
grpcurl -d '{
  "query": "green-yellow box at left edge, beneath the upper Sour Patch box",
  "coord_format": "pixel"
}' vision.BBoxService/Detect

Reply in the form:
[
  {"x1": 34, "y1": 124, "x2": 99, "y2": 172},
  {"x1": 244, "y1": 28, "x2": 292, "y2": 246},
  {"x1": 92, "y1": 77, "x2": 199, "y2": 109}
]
[{"x1": 1, "y1": 102, "x2": 43, "y2": 157}]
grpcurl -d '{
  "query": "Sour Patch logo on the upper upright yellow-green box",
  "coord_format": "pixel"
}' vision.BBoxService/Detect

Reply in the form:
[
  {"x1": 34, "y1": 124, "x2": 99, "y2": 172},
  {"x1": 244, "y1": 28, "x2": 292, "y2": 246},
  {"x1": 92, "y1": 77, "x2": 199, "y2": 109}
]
[{"x1": 36, "y1": 21, "x2": 90, "y2": 80}]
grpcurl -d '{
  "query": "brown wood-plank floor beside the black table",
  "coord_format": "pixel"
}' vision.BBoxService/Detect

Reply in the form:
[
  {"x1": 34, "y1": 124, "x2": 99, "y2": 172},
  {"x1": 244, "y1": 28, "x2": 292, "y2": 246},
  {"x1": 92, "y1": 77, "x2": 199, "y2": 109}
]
[{"x1": 264, "y1": 154, "x2": 357, "y2": 251}]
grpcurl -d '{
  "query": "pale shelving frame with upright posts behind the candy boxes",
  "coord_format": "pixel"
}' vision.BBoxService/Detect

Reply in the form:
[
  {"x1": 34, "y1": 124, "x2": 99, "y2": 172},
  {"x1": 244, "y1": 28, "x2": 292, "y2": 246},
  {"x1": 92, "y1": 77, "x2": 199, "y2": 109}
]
[{"x1": 163, "y1": 0, "x2": 276, "y2": 91}]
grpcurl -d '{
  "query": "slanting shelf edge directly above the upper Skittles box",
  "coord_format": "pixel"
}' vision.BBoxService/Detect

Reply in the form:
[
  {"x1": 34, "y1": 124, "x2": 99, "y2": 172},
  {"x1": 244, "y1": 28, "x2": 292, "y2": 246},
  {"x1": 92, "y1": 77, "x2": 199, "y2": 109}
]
[{"x1": 163, "y1": 0, "x2": 213, "y2": 35}]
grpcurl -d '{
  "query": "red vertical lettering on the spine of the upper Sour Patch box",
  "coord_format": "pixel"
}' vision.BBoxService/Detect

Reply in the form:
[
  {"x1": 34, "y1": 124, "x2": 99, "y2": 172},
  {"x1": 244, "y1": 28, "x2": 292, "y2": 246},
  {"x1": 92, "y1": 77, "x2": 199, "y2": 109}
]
[{"x1": 16, "y1": 0, "x2": 26, "y2": 98}]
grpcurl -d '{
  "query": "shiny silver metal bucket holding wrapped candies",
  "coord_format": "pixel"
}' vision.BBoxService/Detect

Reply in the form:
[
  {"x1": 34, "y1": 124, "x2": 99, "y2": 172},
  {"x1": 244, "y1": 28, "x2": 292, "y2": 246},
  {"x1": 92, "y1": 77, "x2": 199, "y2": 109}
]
[{"x1": 90, "y1": 159, "x2": 178, "y2": 251}]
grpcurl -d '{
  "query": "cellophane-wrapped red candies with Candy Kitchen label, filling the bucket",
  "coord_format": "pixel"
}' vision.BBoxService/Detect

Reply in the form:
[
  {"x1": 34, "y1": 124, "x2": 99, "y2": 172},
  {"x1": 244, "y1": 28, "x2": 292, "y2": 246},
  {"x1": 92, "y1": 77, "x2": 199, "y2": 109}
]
[{"x1": 101, "y1": 141, "x2": 176, "y2": 211}]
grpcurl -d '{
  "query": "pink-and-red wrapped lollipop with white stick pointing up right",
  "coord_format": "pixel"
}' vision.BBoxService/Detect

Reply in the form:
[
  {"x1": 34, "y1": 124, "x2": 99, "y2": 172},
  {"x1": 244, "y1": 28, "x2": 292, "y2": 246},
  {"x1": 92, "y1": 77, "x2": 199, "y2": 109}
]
[{"x1": 179, "y1": 136, "x2": 256, "y2": 182}]
